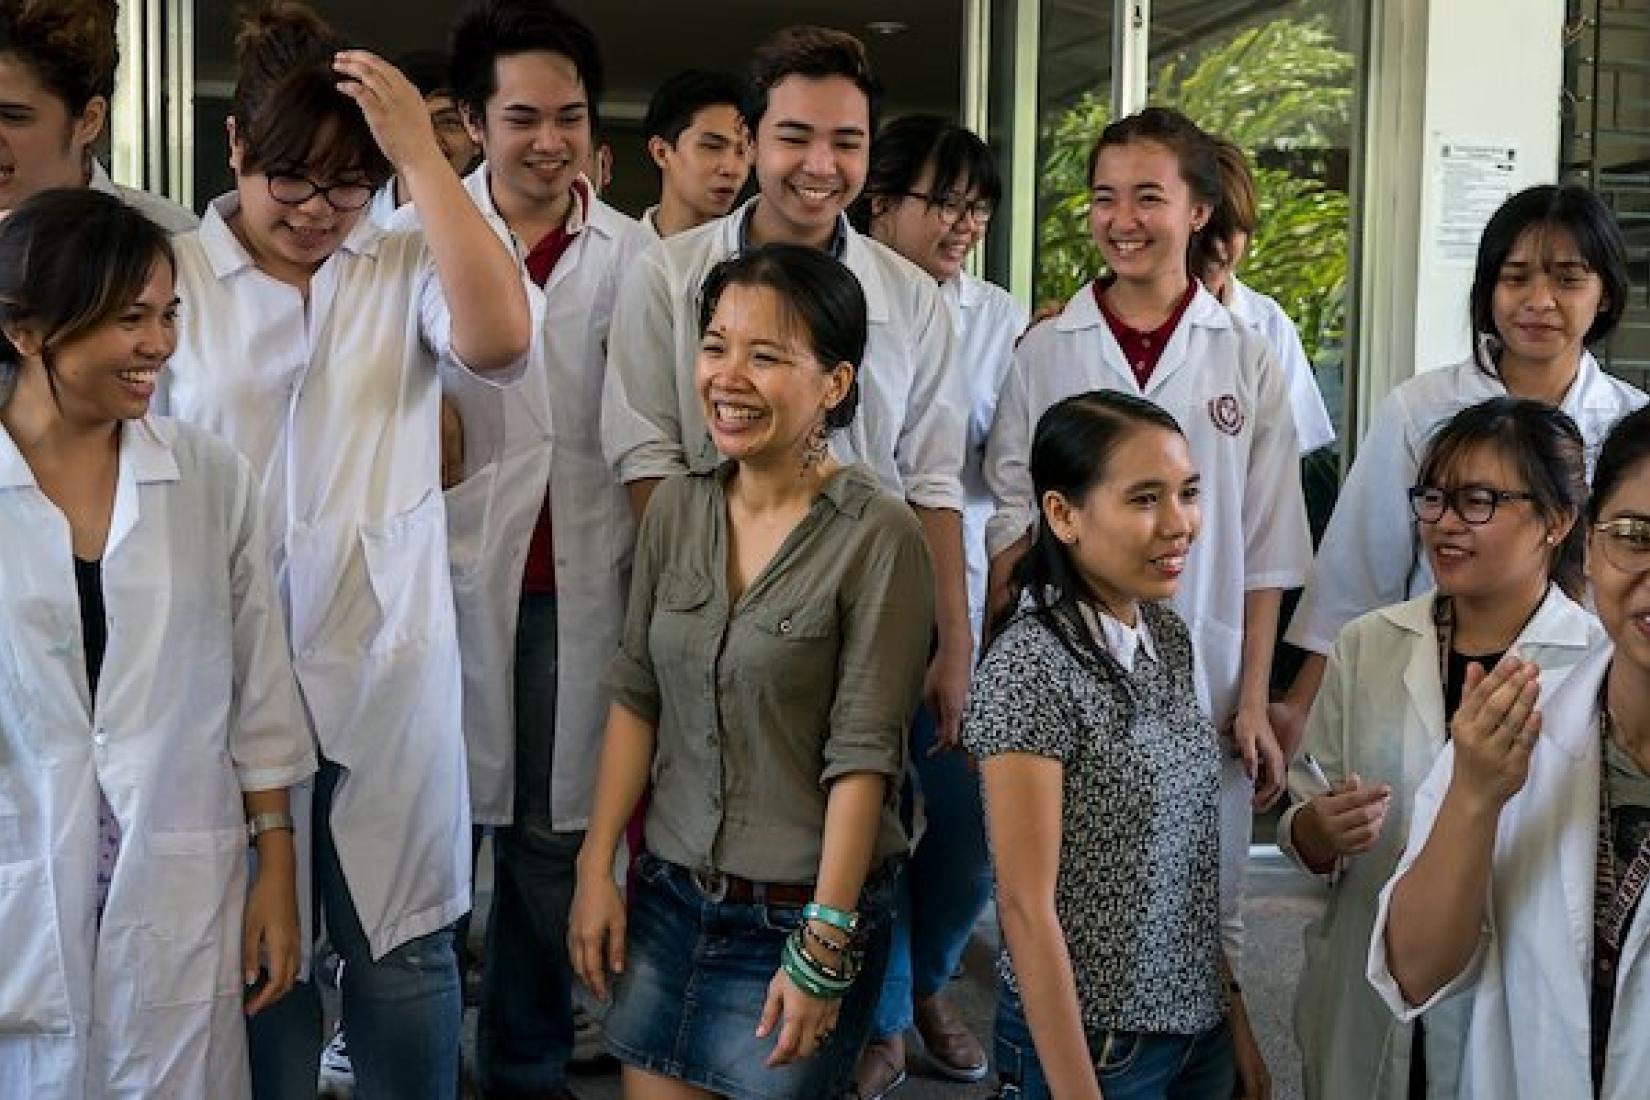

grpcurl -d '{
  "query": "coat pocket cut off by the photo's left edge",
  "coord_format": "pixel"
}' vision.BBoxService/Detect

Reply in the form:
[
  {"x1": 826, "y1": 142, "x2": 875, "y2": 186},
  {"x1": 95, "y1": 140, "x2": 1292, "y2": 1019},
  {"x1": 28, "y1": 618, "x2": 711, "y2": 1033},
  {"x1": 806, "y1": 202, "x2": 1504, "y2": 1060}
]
[{"x1": 0, "y1": 859, "x2": 74, "y2": 1036}]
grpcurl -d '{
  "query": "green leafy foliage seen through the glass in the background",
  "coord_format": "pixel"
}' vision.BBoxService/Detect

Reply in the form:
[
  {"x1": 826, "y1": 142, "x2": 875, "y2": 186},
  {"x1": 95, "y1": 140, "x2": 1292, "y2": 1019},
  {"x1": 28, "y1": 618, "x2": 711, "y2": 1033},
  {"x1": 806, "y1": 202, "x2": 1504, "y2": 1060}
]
[{"x1": 1036, "y1": 16, "x2": 1355, "y2": 361}]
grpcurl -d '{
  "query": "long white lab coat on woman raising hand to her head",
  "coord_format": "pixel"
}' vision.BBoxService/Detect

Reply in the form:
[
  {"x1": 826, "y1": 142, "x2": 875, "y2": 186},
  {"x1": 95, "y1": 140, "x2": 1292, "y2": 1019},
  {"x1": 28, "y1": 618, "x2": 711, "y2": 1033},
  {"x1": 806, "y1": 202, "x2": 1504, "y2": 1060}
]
[{"x1": 162, "y1": 195, "x2": 526, "y2": 958}]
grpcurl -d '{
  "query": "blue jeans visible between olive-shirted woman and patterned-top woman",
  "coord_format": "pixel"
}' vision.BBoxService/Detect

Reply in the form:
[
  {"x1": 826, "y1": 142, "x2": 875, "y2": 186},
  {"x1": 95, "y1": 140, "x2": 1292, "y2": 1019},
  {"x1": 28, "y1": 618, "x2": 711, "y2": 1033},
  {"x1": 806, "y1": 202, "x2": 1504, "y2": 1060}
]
[{"x1": 871, "y1": 706, "x2": 992, "y2": 1037}]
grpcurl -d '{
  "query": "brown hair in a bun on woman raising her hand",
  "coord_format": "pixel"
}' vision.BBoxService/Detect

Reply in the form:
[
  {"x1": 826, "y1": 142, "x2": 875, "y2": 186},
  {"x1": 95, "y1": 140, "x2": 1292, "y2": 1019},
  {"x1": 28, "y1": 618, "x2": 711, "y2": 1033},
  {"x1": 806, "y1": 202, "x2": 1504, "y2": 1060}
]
[{"x1": 233, "y1": 0, "x2": 393, "y2": 186}]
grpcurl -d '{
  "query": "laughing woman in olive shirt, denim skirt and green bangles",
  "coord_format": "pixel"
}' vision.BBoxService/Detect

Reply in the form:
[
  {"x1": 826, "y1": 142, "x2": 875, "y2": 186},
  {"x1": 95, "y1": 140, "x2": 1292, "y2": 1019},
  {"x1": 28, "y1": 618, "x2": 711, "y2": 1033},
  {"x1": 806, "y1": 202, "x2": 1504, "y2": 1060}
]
[{"x1": 569, "y1": 244, "x2": 934, "y2": 1100}]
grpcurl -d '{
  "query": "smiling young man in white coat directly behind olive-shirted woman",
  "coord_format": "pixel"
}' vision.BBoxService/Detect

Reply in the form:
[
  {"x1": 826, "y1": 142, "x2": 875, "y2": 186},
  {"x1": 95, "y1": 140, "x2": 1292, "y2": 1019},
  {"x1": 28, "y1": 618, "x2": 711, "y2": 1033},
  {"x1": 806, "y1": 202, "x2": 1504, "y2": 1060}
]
[{"x1": 602, "y1": 26, "x2": 972, "y2": 775}]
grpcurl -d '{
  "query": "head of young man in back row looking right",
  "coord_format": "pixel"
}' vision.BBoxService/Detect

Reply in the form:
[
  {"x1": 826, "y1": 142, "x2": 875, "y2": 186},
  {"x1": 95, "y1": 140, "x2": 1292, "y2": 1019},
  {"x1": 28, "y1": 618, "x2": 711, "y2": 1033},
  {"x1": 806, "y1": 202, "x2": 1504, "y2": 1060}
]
[{"x1": 642, "y1": 69, "x2": 751, "y2": 239}]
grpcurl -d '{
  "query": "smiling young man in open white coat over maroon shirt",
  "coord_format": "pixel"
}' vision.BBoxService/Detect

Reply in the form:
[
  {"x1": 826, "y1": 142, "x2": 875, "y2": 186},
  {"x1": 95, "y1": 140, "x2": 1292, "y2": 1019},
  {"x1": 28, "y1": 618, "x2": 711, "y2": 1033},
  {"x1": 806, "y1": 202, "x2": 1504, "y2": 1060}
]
[{"x1": 412, "y1": 0, "x2": 647, "y2": 1097}]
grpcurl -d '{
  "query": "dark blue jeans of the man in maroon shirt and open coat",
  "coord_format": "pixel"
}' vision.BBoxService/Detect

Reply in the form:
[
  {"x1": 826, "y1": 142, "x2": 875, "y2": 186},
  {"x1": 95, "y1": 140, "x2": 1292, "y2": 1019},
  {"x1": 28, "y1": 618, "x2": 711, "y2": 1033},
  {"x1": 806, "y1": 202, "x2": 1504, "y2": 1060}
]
[{"x1": 477, "y1": 592, "x2": 584, "y2": 1092}]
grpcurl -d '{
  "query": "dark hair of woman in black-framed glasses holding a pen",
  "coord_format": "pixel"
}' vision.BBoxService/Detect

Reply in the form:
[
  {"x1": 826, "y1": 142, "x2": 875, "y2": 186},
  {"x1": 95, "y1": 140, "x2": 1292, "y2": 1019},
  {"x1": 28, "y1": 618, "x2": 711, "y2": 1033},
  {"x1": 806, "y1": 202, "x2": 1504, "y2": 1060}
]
[{"x1": 1416, "y1": 397, "x2": 1587, "y2": 600}]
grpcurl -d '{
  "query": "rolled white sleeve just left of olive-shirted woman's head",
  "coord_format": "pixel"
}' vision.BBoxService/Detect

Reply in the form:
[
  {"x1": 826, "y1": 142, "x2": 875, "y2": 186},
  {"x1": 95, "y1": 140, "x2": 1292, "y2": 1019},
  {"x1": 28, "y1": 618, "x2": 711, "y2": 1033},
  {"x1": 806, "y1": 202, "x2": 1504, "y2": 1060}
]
[{"x1": 601, "y1": 242, "x2": 688, "y2": 483}]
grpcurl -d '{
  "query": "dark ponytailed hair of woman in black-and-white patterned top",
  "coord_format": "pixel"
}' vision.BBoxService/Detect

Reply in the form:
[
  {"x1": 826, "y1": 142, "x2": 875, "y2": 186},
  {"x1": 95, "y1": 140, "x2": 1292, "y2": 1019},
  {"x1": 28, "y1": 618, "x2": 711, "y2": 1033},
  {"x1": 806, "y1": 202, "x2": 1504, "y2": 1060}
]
[{"x1": 992, "y1": 389, "x2": 1183, "y2": 656}]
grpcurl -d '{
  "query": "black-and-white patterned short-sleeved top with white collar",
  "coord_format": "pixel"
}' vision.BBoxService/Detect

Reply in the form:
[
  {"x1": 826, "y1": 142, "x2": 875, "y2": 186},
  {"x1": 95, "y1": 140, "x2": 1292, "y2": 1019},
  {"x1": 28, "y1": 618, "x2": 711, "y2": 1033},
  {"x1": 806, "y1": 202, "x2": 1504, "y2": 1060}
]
[{"x1": 962, "y1": 604, "x2": 1226, "y2": 1037}]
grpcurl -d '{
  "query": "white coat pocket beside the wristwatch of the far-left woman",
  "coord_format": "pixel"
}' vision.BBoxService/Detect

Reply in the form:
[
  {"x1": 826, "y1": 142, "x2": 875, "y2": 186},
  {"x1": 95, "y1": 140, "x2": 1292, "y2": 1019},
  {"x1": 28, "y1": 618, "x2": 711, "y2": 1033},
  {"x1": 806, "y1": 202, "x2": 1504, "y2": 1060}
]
[{"x1": 139, "y1": 828, "x2": 246, "y2": 1008}]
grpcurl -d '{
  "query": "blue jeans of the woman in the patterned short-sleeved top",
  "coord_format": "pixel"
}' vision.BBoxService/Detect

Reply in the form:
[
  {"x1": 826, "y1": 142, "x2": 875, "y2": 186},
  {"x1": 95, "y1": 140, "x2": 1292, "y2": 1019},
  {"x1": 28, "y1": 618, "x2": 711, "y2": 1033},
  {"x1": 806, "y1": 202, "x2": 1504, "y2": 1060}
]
[{"x1": 997, "y1": 986, "x2": 1238, "y2": 1100}]
